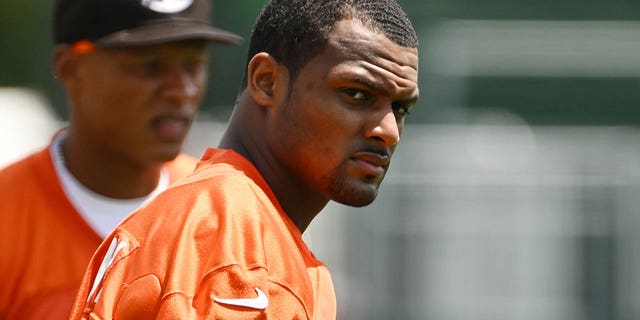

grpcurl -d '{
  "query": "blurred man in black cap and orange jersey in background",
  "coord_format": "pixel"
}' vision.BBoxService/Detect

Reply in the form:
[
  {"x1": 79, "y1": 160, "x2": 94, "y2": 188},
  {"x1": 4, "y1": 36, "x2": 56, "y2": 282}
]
[{"x1": 0, "y1": 0, "x2": 239, "y2": 319}]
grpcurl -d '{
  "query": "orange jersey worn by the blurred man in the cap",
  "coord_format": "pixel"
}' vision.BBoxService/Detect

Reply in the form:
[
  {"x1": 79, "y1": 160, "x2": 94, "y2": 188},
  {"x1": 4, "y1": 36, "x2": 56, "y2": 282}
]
[{"x1": 0, "y1": 144, "x2": 196, "y2": 319}]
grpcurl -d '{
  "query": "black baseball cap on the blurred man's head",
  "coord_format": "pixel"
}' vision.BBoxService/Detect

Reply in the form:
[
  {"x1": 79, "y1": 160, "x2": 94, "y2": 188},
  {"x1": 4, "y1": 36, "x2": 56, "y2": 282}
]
[{"x1": 53, "y1": 0, "x2": 241, "y2": 47}]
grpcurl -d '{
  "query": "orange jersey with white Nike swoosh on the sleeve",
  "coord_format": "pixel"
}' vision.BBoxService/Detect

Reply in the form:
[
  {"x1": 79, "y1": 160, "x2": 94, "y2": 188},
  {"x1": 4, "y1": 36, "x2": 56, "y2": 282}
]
[{"x1": 71, "y1": 149, "x2": 336, "y2": 320}]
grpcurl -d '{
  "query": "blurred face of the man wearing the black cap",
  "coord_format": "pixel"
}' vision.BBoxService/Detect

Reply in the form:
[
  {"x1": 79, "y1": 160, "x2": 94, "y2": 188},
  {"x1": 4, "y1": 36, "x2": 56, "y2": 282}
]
[{"x1": 67, "y1": 41, "x2": 208, "y2": 162}]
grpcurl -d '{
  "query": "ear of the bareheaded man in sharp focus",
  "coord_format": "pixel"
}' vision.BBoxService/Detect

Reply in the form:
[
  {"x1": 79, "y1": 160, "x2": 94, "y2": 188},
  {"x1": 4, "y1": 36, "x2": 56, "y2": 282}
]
[{"x1": 247, "y1": 52, "x2": 288, "y2": 107}]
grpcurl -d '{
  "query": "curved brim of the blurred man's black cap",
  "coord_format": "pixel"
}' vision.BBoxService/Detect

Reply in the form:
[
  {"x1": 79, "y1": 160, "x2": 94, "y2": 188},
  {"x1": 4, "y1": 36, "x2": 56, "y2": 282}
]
[{"x1": 95, "y1": 21, "x2": 242, "y2": 47}]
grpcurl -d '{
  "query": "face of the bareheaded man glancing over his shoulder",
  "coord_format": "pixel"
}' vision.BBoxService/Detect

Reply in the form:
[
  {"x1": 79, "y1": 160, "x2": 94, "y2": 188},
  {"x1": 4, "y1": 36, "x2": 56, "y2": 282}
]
[{"x1": 268, "y1": 20, "x2": 418, "y2": 206}]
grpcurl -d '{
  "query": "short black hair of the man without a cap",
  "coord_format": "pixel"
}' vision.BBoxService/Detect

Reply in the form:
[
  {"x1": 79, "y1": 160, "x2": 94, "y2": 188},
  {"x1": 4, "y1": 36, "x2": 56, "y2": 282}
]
[{"x1": 242, "y1": 0, "x2": 418, "y2": 89}]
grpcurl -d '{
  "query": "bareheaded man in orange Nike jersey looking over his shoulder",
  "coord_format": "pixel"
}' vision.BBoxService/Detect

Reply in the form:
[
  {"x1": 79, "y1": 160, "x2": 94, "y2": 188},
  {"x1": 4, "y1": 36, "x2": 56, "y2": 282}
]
[{"x1": 72, "y1": 0, "x2": 418, "y2": 320}]
